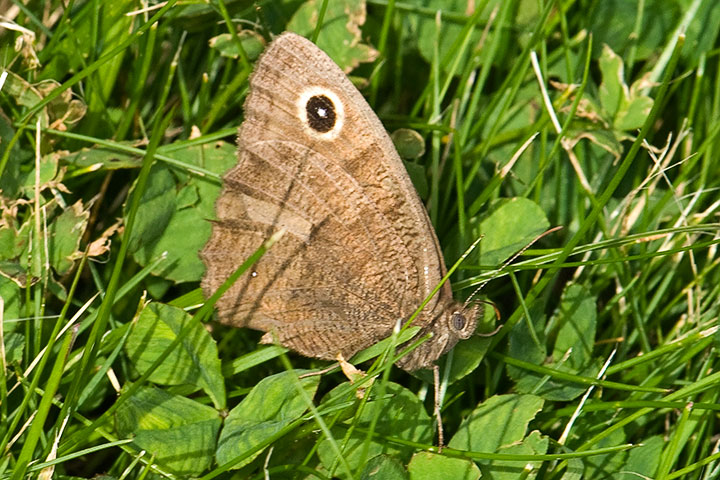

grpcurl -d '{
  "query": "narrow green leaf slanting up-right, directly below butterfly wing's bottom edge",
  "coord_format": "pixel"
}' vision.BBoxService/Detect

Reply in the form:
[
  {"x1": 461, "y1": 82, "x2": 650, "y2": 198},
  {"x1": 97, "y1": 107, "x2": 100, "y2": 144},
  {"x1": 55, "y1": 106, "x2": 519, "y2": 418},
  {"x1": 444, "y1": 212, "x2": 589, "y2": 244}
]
[{"x1": 217, "y1": 370, "x2": 320, "y2": 468}]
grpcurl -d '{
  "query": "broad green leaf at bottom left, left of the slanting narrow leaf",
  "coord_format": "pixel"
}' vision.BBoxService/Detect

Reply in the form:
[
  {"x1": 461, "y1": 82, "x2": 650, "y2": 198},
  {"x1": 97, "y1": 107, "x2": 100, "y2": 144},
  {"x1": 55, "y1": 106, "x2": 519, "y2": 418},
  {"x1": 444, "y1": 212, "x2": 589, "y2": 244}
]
[{"x1": 115, "y1": 387, "x2": 221, "y2": 475}]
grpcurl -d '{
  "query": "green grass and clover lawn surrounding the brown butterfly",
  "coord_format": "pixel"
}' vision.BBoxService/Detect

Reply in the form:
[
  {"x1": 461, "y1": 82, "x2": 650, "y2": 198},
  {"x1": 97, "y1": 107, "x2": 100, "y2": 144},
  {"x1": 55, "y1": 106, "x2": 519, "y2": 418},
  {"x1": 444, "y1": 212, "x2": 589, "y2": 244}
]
[{"x1": 0, "y1": 0, "x2": 720, "y2": 479}]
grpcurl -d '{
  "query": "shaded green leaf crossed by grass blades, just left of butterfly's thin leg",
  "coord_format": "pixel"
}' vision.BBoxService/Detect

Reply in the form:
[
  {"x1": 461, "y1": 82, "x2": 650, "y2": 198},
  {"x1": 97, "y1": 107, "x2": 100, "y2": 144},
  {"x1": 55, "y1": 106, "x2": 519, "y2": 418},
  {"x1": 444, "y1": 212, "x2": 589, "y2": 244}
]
[{"x1": 318, "y1": 382, "x2": 432, "y2": 478}]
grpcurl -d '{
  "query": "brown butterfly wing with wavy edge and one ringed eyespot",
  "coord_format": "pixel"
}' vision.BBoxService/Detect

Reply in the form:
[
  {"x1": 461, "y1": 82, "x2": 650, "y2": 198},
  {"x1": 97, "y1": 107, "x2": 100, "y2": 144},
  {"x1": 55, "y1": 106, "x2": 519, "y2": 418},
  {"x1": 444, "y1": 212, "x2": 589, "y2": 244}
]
[{"x1": 201, "y1": 34, "x2": 451, "y2": 359}]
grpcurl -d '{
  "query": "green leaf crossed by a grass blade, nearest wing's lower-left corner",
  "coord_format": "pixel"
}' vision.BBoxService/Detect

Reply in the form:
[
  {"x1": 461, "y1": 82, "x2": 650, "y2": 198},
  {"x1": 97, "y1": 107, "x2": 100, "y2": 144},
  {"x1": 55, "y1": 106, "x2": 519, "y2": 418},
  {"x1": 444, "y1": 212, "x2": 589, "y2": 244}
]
[{"x1": 125, "y1": 303, "x2": 225, "y2": 408}]
